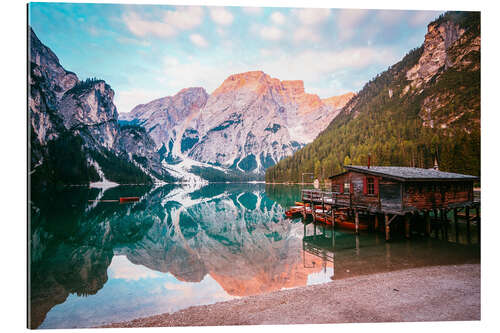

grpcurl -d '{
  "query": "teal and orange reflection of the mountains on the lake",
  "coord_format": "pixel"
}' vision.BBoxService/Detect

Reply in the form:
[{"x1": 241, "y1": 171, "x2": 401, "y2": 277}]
[{"x1": 31, "y1": 184, "x2": 320, "y2": 327}]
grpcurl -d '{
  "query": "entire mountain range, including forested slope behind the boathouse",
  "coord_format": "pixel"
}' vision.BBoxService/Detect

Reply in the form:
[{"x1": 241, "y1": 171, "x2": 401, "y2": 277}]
[{"x1": 28, "y1": 12, "x2": 480, "y2": 186}]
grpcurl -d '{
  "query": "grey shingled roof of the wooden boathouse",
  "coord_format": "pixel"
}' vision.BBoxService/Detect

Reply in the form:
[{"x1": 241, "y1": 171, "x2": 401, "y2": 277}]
[{"x1": 330, "y1": 165, "x2": 479, "y2": 181}]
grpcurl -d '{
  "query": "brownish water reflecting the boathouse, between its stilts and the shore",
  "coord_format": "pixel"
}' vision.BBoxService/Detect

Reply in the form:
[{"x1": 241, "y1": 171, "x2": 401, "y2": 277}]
[{"x1": 302, "y1": 221, "x2": 480, "y2": 280}]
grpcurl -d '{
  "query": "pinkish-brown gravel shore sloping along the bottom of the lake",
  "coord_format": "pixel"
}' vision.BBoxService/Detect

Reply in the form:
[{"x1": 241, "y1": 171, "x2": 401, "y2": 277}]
[{"x1": 105, "y1": 264, "x2": 481, "y2": 327}]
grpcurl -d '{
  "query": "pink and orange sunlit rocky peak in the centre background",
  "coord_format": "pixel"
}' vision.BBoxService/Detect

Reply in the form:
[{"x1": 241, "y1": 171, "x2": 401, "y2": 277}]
[{"x1": 120, "y1": 71, "x2": 352, "y2": 178}]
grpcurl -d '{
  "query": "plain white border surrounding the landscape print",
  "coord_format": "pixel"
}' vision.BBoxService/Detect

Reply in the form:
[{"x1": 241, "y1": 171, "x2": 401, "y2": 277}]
[{"x1": 0, "y1": 0, "x2": 500, "y2": 333}]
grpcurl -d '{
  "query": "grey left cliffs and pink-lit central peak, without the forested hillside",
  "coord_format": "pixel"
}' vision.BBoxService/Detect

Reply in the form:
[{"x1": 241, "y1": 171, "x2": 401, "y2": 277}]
[{"x1": 29, "y1": 28, "x2": 354, "y2": 186}]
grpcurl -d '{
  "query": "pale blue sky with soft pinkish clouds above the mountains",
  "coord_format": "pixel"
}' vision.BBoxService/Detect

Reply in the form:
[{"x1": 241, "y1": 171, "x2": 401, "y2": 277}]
[{"x1": 28, "y1": 3, "x2": 442, "y2": 113}]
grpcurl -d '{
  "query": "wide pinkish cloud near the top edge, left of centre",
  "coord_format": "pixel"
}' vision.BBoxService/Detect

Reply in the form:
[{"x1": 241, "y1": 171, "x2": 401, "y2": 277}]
[{"x1": 122, "y1": 7, "x2": 204, "y2": 38}]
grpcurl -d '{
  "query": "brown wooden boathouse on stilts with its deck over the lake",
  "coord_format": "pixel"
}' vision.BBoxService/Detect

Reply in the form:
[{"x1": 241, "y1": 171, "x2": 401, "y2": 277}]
[{"x1": 302, "y1": 165, "x2": 480, "y2": 240}]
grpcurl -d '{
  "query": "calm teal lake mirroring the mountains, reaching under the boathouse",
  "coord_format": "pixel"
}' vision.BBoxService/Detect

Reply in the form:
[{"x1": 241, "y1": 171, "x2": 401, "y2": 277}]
[{"x1": 29, "y1": 184, "x2": 480, "y2": 328}]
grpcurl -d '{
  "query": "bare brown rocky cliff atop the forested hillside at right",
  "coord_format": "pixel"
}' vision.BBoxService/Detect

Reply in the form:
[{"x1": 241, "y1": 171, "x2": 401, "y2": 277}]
[{"x1": 405, "y1": 13, "x2": 481, "y2": 133}]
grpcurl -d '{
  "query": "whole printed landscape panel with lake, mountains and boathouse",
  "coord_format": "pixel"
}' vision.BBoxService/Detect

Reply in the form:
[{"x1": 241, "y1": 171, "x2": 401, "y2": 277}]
[{"x1": 27, "y1": 3, "x2": 481, "y2": 329}]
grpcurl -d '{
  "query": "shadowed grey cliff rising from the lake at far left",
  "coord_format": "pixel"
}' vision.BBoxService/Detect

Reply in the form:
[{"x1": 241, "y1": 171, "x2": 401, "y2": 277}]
[{"x1": 28, "y1": 28, "x2": 171, "y2": 188}]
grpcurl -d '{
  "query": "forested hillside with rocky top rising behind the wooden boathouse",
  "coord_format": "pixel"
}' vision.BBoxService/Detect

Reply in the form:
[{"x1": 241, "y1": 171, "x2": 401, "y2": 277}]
[{"x1": 266, "y1": 12, "x2": 480, "y2": 182}]
